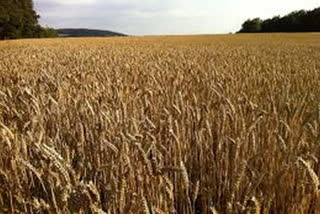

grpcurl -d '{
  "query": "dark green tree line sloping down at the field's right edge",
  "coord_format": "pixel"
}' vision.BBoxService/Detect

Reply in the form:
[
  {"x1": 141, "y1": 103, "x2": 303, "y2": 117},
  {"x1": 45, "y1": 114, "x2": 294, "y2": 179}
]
[{"x1": 239, "y1": 7, "x2": 320, "y2": 33}]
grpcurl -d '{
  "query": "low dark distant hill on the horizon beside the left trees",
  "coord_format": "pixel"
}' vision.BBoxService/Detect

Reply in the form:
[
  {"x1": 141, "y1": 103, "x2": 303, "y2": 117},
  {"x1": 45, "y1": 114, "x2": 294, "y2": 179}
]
[{"x1": 56, "y1": 28, "x2": 127, "y2": 37}]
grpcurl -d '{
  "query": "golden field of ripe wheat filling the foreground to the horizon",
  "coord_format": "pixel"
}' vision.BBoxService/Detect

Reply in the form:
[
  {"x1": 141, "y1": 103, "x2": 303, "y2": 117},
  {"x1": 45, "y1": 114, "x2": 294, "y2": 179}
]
[{"x1": 0, "y1": 34, "x2": 320, "y2": 214}]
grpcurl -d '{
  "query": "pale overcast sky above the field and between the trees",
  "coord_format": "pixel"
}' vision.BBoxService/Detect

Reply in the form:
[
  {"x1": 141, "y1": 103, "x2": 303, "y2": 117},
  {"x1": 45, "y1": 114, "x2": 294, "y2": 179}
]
[{"x1": 34, "y1": 0, "x2": 320, "y2": 35}]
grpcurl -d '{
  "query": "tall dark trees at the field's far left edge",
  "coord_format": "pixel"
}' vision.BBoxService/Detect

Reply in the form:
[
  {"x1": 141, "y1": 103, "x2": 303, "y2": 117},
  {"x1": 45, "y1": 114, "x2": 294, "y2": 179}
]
[{"x1": 0, "y1": 0, "x2": 58, "y2": 40}]
